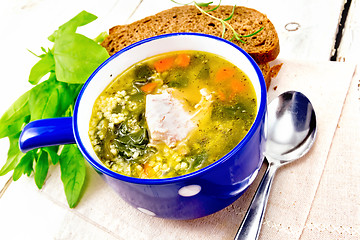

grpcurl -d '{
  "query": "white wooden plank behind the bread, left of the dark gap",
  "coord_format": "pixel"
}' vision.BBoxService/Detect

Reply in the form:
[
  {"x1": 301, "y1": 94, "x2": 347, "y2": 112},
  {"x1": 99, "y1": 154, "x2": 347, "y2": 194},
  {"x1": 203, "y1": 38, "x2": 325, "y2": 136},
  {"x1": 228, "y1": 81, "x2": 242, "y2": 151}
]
[{"x1": 124, "y1": 0, "x2": 344, "y2": 61}]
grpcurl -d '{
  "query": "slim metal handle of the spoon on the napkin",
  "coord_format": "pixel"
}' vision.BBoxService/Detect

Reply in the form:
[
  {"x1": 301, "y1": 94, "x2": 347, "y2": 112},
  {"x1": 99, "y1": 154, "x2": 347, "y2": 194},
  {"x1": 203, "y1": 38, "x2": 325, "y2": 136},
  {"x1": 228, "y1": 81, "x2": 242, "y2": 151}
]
[{"x1": 235, "y1": 162, "x2": 279, "y2": 240}]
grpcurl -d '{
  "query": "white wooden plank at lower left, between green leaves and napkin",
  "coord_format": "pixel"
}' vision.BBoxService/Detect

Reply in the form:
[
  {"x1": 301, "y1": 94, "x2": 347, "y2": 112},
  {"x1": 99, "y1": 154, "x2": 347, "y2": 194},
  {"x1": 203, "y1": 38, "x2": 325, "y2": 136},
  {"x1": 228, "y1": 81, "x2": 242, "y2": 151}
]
[{"x1": 0, "y1": 173, "x2": 122, "y2": 240}]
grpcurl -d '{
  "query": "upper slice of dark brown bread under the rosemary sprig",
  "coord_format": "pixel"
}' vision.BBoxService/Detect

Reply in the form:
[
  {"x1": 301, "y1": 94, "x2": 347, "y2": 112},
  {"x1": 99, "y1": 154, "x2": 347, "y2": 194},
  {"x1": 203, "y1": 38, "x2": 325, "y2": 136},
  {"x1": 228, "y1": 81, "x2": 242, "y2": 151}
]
[{"x1": 101, "y1": 6, "x2": 280, "y2": 64}]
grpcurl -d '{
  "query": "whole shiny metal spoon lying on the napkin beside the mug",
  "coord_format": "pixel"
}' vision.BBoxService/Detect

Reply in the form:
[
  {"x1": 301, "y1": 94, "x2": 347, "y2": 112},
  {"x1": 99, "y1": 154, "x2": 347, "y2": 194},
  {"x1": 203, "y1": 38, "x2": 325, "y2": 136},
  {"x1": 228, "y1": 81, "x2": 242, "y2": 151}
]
[{"x1": 235, "y1": 91, "x2": 316, "y2": 240}]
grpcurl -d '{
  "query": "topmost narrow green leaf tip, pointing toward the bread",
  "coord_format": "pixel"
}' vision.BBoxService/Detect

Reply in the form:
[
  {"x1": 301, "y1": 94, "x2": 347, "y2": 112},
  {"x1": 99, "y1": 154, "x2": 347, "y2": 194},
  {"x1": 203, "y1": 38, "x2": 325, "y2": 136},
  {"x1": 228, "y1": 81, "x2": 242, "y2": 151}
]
[{"x1": 48, "y1": 11, "x2": 97, "y2": 42}]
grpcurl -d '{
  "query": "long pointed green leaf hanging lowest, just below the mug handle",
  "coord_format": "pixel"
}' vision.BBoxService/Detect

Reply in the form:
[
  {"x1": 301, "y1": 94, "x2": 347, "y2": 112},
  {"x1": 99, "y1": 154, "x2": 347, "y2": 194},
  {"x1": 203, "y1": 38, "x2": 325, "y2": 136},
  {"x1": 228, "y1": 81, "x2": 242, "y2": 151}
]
[{"x1": 60, "y1": 145, "x2": 86, "y2": 208}]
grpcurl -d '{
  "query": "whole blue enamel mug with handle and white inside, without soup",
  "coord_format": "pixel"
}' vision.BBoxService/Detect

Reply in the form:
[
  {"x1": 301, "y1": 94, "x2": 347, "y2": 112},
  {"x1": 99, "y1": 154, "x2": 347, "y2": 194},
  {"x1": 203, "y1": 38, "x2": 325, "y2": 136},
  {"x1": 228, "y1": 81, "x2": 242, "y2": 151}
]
[{"x1": 20, "y1": 33, "x2": 267, "y2": 219}]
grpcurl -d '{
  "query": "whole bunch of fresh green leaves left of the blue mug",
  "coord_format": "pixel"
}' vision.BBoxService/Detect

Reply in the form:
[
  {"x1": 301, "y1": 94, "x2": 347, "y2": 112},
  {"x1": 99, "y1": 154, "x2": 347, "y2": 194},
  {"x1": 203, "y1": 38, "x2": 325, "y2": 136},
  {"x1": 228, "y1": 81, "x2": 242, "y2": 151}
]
[{"x1": 0, "y1": 11, "x2": 109, "y2": 207}]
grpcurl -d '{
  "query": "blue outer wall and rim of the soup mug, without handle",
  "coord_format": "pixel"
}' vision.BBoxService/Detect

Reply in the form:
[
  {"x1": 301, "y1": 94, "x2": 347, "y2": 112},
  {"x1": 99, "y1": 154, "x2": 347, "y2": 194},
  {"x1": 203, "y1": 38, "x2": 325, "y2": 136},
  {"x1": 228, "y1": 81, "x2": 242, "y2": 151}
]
[{"x1": 73, "y1": 33, "x2": 266, "y2": 219}]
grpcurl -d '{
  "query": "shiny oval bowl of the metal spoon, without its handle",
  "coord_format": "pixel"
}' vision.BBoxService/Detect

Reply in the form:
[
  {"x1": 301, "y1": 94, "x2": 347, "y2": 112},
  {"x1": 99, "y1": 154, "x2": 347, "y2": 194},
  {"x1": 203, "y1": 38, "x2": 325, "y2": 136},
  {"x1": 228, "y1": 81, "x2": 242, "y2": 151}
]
[{"x1": 265, "y1": 91, "x2": 316, "y2": 163}]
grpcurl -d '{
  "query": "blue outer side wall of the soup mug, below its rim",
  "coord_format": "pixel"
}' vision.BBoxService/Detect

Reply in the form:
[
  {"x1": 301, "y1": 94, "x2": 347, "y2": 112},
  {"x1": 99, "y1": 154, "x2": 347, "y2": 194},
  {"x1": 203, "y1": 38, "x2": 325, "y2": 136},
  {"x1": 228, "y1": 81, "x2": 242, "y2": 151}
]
[{"x1": 101, "y1": 112, "x2": 265, "y2": 220}]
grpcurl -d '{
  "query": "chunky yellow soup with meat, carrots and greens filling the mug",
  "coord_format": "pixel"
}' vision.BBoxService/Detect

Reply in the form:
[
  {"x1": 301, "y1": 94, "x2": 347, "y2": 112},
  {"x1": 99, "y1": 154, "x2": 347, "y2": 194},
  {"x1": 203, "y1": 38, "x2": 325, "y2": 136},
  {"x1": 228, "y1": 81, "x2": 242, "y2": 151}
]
[{"x1": 89, "y1": 51, "x2": 257, "y2": 178}]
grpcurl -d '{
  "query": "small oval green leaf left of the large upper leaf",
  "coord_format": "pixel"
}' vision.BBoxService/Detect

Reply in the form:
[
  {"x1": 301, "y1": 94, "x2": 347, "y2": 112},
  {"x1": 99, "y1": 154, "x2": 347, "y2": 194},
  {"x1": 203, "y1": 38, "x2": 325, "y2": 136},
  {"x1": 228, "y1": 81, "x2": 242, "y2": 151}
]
[{"x1": 29, "y1": 51, "x2": 55, "y2": 85}]
